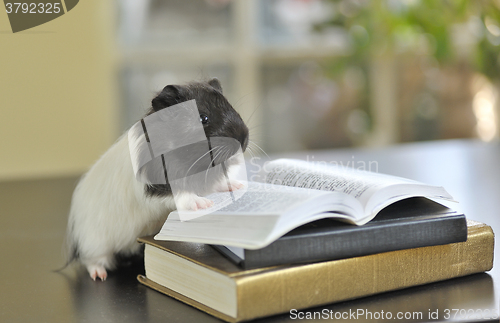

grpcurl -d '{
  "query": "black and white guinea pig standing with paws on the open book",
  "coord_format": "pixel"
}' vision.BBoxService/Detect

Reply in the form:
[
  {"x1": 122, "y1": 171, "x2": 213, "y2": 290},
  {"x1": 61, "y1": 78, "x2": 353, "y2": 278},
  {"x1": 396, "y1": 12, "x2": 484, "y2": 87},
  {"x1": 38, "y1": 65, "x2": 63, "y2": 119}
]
[{"x1": 66, "y1": 78, "x2": 249, "y2": 281}]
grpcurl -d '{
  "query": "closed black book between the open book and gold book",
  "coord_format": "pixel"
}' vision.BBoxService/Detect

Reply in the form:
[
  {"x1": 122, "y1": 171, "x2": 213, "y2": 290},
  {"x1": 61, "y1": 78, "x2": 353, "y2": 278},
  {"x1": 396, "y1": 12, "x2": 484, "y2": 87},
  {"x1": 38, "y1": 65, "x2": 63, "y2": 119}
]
[{"x1": 214, "y1": 197, "x2": 467, "y2": 269}]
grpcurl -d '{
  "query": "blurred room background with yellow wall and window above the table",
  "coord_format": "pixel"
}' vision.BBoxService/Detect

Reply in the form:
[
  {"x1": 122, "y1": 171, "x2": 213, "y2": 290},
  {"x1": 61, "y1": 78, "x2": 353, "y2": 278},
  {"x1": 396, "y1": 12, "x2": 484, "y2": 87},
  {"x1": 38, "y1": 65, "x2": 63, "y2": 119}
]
[{"x1": 0, "y1": 0, "x2": 500, "y2": 179}]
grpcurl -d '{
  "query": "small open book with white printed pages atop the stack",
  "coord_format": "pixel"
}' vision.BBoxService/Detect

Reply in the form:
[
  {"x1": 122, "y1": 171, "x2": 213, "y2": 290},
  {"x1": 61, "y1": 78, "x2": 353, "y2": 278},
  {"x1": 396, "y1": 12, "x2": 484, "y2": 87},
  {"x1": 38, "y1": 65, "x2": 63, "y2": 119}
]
[{"x1": 155, "y1": 159, "x2": 453, "y2": 249}]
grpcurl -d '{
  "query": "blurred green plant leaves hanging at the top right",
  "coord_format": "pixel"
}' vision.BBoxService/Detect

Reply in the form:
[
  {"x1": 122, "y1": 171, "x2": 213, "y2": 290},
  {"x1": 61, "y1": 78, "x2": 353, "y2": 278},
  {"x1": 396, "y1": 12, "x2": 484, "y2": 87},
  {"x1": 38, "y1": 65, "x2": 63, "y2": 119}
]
[{"x1": 317, "y1": 0, "x2": 500, "y2": 81}]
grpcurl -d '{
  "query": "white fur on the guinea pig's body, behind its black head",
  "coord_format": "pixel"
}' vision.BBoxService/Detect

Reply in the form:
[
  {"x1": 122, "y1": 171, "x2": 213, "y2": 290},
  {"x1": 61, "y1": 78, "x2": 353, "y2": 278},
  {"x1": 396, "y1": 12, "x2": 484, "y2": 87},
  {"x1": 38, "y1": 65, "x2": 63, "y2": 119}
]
[{"x1": 68, "y1": 135, "x2": 175, "y2": 280}]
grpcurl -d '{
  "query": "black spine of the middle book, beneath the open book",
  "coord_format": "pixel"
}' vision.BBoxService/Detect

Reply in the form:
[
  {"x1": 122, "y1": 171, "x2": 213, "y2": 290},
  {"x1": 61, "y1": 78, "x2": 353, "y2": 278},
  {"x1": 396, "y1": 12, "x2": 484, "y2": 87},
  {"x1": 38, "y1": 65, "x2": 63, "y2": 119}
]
[{"x1": 243, "y1": 215, "x2": 467, "y2": 269}]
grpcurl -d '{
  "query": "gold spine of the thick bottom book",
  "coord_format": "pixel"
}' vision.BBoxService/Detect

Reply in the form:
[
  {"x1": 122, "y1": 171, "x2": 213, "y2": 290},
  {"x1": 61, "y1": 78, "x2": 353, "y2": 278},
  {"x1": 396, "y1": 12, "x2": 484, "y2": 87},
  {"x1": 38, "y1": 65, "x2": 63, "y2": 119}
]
[{"x1": 236, "y1": 223, "x2": 494, "y2": 320}]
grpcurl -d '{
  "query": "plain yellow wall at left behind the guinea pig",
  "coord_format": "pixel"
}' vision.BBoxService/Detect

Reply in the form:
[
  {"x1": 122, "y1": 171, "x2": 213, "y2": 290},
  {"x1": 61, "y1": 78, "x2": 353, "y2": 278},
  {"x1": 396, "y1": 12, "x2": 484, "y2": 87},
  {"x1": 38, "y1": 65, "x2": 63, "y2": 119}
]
[{"x1": 0, "y1": 0, "x2": 118, "y2": 180}]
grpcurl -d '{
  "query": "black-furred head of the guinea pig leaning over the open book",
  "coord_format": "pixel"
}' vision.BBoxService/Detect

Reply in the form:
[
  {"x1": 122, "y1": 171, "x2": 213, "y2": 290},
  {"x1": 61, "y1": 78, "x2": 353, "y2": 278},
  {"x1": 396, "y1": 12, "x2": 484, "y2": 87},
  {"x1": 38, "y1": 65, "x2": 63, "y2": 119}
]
[{"x1": 148, "y1": 78, "x2": 249, "y2": 193}]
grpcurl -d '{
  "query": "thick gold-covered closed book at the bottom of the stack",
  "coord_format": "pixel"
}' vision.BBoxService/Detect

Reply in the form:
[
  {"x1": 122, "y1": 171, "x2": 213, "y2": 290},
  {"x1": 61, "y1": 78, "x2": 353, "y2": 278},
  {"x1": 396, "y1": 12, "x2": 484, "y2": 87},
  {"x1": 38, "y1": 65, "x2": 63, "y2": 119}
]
[{"x1": 138, "y1": 220, "x2": 494, "y2": 322}]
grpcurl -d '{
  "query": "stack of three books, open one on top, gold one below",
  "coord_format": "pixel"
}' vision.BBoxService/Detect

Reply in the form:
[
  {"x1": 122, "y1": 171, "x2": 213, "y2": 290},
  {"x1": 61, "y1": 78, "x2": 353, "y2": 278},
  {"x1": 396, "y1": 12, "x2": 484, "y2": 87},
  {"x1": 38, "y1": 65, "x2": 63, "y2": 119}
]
[{"x1": 138, "y1": 160, "x2": 494, "y2": 322}]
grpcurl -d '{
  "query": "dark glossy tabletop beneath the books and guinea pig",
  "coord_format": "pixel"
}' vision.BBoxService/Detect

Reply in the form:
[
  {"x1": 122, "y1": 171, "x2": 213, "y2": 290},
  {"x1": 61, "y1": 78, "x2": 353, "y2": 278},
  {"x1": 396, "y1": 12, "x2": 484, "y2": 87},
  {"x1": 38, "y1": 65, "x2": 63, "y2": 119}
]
[{"x1": 0, "y1": 140, "x2": 500, "y2": 322}]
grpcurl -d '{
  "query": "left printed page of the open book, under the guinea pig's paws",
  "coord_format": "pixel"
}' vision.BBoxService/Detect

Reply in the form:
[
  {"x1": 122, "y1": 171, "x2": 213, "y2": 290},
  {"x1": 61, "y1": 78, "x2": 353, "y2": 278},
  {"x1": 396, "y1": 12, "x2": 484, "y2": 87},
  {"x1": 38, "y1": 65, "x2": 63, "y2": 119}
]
[{"x1": 155, "y1": 182, "x2": 347, "y2": 249}]
